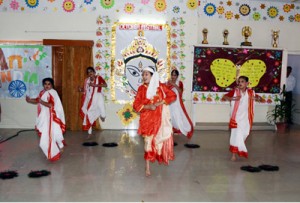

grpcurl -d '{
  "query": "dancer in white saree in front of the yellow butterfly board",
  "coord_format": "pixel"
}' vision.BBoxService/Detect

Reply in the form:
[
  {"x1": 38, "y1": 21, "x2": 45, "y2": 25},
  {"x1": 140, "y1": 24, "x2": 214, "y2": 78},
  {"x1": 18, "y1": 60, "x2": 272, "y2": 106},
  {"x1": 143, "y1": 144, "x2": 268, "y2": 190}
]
[{"x1": 222, "y1": 76, "x2": 262, "y2": 161}]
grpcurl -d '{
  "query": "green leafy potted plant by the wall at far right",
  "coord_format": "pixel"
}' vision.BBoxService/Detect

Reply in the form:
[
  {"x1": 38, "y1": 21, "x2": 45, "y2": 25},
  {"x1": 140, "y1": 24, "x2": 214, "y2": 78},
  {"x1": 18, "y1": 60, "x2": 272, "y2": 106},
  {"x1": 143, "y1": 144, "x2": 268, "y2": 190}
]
[{"x1": 267, "y1": 85, "x2": 298, "y2": 132}]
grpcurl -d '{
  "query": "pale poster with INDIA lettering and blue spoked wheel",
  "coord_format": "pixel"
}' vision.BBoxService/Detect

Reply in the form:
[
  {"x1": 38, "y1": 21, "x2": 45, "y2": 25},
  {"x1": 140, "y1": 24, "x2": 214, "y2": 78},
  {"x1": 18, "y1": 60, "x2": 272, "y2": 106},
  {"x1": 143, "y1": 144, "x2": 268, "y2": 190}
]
[{"x1": 0, "y1": 45, "x2": 52, "y2": 99}]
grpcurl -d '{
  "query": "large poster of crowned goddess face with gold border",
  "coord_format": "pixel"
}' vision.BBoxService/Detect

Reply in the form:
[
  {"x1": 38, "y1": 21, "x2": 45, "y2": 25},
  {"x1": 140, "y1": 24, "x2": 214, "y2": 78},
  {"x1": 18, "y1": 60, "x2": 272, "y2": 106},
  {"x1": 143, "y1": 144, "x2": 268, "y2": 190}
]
[{"x1": 111, "y1": 23, "x2": 170, "y2": 103}]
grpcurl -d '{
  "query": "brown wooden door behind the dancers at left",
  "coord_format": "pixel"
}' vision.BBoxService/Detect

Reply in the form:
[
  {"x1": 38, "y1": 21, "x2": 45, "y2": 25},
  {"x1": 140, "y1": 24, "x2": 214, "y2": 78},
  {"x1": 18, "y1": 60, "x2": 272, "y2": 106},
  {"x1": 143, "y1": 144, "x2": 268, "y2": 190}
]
[{"x1": 43, "y1": 39, "x2": 94, "y2": 130}]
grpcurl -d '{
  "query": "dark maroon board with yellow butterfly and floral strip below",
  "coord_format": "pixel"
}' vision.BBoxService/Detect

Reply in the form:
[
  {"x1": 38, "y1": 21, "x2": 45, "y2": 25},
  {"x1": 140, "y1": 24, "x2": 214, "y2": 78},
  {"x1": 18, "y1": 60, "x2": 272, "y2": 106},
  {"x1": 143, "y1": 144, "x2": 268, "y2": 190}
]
[{"x1": 192, "y1": 46, "x2": 283, "y2": 104}]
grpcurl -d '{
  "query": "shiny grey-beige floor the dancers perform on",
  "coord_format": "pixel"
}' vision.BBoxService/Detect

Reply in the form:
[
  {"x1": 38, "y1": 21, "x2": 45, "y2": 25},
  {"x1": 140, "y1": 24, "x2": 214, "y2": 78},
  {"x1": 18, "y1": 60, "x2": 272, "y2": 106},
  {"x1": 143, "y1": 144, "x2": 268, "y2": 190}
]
[{"x1": 0, "y1": 126, "x2": 300, "y2": 202}]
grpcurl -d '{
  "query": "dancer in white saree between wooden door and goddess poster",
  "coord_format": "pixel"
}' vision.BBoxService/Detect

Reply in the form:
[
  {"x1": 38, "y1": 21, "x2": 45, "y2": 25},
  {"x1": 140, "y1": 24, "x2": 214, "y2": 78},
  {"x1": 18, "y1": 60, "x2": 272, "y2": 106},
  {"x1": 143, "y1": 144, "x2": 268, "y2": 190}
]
[{"x1": 79, "y1": 67, "x2": 107, "y2": 138}]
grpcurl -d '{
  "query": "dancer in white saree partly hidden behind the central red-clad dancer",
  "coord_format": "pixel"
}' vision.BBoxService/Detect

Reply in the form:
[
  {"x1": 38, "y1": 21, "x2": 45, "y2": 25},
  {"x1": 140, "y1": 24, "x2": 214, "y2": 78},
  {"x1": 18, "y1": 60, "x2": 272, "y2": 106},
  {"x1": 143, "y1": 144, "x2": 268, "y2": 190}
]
[{"x1": 167, "y1": 69, "x2": 194, "y2": 139}]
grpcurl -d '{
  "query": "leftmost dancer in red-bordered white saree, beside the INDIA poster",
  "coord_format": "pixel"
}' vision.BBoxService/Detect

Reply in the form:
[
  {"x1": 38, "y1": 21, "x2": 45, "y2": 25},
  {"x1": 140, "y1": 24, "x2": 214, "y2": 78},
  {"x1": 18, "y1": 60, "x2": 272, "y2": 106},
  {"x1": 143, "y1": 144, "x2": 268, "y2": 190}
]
[{"x1": 26, "y1": 78, "x2": 66, "y2": 161}]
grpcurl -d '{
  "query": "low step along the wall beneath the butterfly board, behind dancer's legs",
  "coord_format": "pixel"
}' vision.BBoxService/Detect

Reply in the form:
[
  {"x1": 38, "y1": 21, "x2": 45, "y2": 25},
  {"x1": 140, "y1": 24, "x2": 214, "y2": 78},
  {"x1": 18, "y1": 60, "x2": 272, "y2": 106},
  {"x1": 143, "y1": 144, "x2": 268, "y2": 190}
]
[{"x1": 194, "y1": 122, "x2": 275, "y2": 130}]
